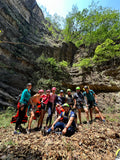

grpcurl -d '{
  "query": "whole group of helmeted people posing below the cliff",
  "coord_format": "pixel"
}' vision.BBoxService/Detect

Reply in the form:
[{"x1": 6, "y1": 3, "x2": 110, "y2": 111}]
[{"x1": 11, "y1": 83, "x2": 105, "y2": 136}]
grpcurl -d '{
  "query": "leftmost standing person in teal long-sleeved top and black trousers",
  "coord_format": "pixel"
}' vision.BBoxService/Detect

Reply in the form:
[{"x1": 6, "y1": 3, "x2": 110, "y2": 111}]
[{"x1": 11, "y1": 83, "x2": 32, "y2": 134}]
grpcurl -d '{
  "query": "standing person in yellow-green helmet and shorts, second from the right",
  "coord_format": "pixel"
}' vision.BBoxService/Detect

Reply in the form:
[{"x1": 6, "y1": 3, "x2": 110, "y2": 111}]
[{"x1": 73, "y1": 87, "x2": 89, "y2": 124}]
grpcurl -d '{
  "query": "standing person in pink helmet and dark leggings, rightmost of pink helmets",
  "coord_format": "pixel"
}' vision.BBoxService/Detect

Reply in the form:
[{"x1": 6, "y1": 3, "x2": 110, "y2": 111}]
[{"x1": 46, "y1": 87, "x2": 57, "y2": 126}]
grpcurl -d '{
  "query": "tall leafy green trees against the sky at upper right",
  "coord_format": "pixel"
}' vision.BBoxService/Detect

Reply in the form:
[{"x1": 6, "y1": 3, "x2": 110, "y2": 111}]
[{"x1": 64, "y1": 2, "x2": 120, "y2": 50}]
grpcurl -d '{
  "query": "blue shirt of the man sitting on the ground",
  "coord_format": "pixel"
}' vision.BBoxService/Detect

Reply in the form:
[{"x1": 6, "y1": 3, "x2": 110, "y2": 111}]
[{"x1": 60, "y1": 110, "x2": 76, "y2": 127}]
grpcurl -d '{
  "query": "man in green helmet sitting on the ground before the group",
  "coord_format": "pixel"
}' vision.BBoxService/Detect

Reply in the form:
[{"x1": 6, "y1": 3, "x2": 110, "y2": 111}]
[{"x1": 42, "y1": 103, "x2": 76, "y2": 136}]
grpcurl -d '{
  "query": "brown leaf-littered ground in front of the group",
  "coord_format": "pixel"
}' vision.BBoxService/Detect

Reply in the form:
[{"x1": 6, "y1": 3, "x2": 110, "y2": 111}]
[{"x1": 0, "y1": 114, "x2": 120, "y2": 160}]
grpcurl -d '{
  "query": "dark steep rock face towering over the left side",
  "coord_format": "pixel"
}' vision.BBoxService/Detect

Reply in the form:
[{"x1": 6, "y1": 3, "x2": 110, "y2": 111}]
[{"x1": 0, "y1": 0, "x2": 77, "y2": 106}]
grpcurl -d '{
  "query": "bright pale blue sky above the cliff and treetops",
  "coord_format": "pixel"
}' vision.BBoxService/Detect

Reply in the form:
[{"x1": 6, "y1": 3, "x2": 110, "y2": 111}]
[{"x1": 36, "y1": 0, "x2": 120, "y2": 18}]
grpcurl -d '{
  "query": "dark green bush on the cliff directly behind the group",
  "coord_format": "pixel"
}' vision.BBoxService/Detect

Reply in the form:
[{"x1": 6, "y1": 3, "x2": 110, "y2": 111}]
[{"x1": 33, "y1": 54, "x2": 70, "y2": 89}]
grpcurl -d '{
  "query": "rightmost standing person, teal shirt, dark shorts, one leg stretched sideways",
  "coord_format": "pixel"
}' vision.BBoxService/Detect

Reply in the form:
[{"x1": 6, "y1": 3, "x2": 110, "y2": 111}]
[{"x1": 83, "y1": 86, "x2": 105, "y2": 122}]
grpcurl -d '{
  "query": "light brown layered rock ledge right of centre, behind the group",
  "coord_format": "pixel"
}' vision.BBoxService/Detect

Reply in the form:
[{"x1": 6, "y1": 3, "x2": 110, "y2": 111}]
[{"x1": 69, "y1": 46, "x2": 120, "y2": 92}]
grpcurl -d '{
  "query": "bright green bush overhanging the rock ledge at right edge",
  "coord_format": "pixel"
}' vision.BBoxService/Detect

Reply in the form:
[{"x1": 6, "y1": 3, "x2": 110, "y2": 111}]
[{"x1": 73, "y1": 39, "x2": 120, "y2": 68}]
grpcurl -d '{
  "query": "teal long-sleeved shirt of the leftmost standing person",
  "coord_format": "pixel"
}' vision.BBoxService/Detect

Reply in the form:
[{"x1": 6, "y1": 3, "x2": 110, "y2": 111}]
[{"x1": 20, "y1": 89, "x2": 31, "y2": 104}]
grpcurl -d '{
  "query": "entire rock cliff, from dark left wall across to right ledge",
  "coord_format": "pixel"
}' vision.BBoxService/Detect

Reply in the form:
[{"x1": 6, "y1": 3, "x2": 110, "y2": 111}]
[{"x1": 0, "y1": 0, "x2": 120, "y2": 110}]
